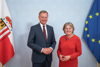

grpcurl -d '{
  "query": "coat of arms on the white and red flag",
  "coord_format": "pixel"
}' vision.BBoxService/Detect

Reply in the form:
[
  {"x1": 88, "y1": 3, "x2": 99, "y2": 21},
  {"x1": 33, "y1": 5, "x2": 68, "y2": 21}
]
[{"x1": 0, "y1": 17, "x2": 12, "y2": 41}]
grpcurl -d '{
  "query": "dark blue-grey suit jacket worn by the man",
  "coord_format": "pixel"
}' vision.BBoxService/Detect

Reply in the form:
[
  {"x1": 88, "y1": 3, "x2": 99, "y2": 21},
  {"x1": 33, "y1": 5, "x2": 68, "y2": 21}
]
[{"x1": 27, "y1": 24, "x2": 56, "y2": 63}]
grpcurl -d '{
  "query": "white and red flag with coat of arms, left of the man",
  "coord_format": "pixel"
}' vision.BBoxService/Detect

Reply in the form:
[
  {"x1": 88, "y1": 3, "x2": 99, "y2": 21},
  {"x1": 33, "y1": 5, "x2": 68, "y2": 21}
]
[{"x1": 0, "y1": 0, "x2": 15, "y2": 65}]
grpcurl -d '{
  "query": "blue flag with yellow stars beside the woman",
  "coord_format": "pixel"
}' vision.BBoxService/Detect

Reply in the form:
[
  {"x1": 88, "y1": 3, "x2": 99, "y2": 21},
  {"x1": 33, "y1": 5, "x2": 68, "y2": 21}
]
[{"x1": 83, "y1": 0, "x2": 100, "y2": 63}]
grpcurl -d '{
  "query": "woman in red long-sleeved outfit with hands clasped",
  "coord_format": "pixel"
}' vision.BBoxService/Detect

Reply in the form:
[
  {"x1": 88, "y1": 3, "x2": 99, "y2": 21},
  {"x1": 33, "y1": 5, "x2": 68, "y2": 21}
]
[{"x1": 57, "y1": 22, "x2": 82, "y2": 67}]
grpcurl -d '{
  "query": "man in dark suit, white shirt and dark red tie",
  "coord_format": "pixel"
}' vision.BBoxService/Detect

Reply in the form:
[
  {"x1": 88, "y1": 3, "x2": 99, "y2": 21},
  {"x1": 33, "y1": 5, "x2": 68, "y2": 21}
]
[{"x1": 27, "y1": 10, "x2": 56, "y2": 67}]
